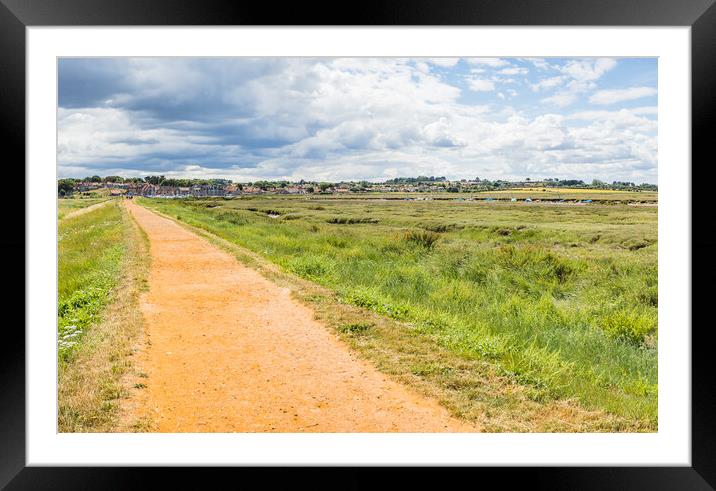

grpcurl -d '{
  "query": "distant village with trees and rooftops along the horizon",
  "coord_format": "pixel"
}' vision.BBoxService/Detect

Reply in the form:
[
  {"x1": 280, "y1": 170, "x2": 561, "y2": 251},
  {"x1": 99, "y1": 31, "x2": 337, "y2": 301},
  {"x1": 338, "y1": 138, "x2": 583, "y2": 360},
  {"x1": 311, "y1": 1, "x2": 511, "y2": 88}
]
[{"x1": 57, "y1": 176, "x2": 657, "y2": 198}]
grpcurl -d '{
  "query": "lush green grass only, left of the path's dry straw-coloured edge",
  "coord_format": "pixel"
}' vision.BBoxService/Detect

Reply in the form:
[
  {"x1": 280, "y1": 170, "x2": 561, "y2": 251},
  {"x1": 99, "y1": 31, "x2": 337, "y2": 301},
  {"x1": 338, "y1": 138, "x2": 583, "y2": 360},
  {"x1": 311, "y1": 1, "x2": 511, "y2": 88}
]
[{"x1": 57, "y1": 200, "x2": 125, "y2": 363}]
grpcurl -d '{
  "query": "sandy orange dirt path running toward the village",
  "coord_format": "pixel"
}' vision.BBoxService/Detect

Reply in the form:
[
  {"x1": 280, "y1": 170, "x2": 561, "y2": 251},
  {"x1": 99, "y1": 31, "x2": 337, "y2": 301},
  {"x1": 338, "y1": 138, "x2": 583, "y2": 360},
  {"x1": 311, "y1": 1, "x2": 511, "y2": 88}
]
[{"x1": 127, "y1": 203, "x2": 476, "y2": 432}]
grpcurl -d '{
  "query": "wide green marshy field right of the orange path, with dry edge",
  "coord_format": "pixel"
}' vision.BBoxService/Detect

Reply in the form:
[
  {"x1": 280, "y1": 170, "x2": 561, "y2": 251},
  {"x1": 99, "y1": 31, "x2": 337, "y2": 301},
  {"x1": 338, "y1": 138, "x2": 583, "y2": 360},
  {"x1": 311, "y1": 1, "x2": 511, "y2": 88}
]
[{"x1": 138, "y1": 193, "x2": 658, "y2": 431}]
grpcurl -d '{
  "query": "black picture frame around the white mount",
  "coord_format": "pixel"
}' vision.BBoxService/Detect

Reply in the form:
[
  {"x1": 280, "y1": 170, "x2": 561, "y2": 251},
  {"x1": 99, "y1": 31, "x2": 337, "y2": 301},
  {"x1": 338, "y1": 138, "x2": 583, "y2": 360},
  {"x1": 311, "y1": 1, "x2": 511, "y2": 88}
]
[{"x1": 0, "y1": 0, "x2": 716, "y2": 490}]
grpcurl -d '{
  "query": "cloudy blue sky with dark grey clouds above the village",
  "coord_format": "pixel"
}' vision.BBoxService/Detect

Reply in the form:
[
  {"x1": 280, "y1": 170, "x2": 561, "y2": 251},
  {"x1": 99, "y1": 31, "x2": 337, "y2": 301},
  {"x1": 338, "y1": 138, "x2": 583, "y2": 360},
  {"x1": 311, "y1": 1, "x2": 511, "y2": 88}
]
[{"x1": 57, "y1": 58, "x2": 657, "y2": 184}]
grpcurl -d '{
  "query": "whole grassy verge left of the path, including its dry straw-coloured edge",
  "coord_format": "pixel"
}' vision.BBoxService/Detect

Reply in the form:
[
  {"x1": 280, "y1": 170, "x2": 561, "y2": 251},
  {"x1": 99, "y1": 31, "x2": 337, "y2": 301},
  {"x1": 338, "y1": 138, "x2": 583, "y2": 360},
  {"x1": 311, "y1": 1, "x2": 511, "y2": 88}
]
[{"x1": 58, "y1": 203, "x2": 149, "y2": 432}]
